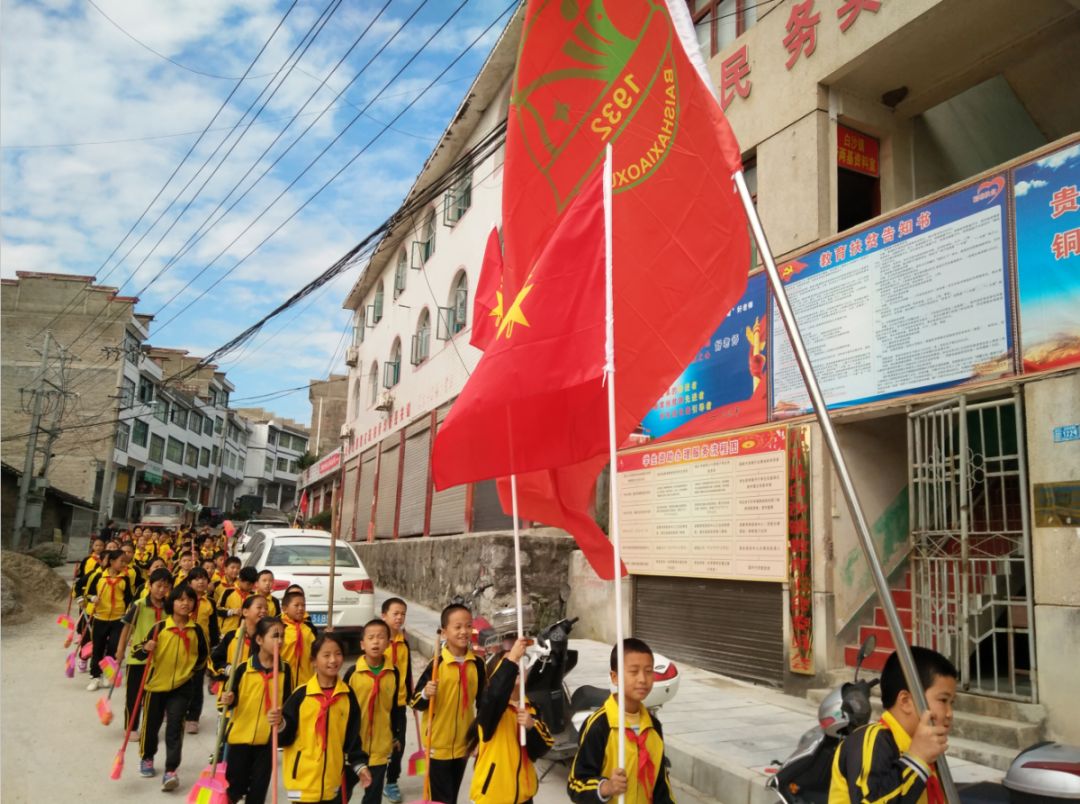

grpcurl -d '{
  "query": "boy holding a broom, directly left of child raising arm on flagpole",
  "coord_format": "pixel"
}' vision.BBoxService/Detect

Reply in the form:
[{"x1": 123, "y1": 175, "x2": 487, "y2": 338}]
[{"x1": 409, "y1": 604, "x2": 484, "y2": 804}]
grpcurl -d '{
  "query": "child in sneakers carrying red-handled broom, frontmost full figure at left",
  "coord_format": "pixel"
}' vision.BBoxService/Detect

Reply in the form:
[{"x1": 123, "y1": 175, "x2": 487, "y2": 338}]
[{"x1": 136, "y1": 586, "x2": 210, "y2": 790}]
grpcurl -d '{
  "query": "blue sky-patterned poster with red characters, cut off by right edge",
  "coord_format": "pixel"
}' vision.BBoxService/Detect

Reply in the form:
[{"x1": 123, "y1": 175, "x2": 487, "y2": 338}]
[{"x1": 1013, "y1": 143, "x2": 1080, "y2": 372}]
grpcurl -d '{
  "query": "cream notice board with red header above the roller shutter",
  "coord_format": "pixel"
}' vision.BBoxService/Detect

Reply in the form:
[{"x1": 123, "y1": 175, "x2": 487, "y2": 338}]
[{"x1": 618, "y1": 428, "x2": 787, "y2": 581}]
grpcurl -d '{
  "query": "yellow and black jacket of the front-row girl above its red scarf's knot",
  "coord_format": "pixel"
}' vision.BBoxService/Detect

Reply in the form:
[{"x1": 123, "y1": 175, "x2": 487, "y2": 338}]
[{"x1": 278, "y1": 675, "x2": 367, "y2": 802}]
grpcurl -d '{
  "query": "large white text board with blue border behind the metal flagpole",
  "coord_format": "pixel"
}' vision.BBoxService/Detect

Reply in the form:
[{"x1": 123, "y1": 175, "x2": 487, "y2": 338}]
[{"x1": 771, "y1": 174, "x2": 1013, "y2": 417}]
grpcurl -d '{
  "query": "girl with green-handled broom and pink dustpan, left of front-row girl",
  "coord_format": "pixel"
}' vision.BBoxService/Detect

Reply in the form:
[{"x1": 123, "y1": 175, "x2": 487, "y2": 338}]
[{"x1": 221, "y1": 617, "x2": 293, "y2": 804}]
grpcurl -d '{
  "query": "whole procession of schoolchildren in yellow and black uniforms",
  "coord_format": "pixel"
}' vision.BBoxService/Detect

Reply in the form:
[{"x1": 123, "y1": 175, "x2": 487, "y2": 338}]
[{"x1": 67, "y1": 528, "x2": 957, "y2": 804}]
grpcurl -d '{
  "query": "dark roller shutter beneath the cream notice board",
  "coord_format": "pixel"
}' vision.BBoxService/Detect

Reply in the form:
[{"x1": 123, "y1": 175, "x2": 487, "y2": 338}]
[{"x1": 633, "y1": 575, "x2": 784, "y2": 686}]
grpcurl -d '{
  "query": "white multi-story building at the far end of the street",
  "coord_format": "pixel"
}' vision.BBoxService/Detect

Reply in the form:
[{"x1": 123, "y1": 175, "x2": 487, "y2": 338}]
[{"x1": 237, "y1": 407, "x2": 309, "y2": 511}]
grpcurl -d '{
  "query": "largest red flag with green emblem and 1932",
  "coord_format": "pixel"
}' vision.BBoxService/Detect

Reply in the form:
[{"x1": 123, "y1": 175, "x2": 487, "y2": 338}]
[{"x1": 490, "y1": 0, "x2": 750, "y2": 577}]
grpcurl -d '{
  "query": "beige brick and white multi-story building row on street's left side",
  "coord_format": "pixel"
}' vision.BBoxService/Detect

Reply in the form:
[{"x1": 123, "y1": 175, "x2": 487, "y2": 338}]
[{"x1": 2, "y1": 272, "x2": 246, "y2": 540}]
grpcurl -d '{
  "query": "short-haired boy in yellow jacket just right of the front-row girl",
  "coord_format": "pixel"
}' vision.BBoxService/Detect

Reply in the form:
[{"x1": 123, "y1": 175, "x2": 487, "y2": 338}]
[{"x1": 343, "y1": 619, "x2": 400, "y2": 804}]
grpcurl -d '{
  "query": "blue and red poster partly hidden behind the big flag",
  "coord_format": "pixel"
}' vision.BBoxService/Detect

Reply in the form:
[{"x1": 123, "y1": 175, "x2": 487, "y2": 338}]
[{"x1": 642, "y1": 273, "x2": 769, "y2": 441}]
